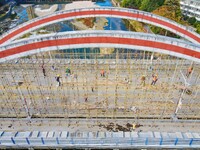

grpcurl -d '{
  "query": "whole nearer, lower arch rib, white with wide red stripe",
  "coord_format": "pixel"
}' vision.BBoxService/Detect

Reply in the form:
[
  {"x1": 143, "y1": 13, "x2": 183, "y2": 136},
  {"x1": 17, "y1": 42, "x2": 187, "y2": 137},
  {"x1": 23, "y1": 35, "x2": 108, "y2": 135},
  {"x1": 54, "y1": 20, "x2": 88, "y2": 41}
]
[{"x1": 0, "y1": 30, "x2": 200, "y2": 63}]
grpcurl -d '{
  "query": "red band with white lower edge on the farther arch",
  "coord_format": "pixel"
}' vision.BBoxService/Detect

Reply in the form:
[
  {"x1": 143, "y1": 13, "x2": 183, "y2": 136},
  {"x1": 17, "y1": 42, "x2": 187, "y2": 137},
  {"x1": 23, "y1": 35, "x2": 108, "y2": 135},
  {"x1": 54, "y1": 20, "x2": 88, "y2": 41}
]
[{"x1": 0, "y1": 9, "x2": 200, "y2": 44}]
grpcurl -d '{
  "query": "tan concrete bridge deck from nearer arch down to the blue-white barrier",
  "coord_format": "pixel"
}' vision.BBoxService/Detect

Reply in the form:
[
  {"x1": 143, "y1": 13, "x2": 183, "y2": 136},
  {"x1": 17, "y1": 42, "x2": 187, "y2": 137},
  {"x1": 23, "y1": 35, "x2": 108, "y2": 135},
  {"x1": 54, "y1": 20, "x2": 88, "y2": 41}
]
[{"x1": 0, "y1": 55, "x2": 200, "y2": 131}]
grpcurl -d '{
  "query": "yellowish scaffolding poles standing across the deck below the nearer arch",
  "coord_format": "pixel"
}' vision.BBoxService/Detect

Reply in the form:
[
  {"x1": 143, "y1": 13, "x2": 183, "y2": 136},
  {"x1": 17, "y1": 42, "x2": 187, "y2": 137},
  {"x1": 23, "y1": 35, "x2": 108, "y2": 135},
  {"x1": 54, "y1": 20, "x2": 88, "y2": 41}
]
[{"x1": 0, "y1": 49, "x2": 200, "y2": 122}]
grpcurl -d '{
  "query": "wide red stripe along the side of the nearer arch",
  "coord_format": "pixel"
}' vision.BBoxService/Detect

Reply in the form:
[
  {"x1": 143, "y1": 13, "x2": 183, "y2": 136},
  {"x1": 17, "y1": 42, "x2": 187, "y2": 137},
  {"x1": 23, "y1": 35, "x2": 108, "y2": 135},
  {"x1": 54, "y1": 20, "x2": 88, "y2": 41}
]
[{"x1": 0, "y1": 36, "x2": 200, "y2": 59}]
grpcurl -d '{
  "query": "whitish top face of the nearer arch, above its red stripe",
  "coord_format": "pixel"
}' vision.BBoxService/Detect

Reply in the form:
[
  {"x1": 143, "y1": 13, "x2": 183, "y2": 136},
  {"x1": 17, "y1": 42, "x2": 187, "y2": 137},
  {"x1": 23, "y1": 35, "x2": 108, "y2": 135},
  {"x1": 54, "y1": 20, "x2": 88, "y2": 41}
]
[{"x1": 0, "y1": 30, "x2": 200, "y2": 52}]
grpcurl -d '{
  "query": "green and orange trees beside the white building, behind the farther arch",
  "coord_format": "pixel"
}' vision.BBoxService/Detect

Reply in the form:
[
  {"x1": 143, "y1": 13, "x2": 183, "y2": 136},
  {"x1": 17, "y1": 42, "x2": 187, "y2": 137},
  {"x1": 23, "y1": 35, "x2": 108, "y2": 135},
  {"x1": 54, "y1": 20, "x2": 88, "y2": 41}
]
[{"x1": 121, "y1": 0, "x2": 200, "y2": 37}]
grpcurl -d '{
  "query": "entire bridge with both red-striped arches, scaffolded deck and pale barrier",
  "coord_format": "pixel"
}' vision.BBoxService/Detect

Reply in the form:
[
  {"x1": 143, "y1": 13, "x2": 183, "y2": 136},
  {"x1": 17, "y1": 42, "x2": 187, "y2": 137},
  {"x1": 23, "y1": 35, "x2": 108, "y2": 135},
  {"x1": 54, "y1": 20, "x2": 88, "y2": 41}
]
[{"x1": 0, "y1": 8, "x2": 200, "y2": 148}]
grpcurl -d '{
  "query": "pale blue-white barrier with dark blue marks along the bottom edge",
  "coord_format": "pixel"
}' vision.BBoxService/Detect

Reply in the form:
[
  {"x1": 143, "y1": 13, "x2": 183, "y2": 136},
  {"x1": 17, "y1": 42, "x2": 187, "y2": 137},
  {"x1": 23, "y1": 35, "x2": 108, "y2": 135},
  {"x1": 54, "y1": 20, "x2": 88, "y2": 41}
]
[{"x1": 0, "y1": 131, "x2": 200, "y2": 148}]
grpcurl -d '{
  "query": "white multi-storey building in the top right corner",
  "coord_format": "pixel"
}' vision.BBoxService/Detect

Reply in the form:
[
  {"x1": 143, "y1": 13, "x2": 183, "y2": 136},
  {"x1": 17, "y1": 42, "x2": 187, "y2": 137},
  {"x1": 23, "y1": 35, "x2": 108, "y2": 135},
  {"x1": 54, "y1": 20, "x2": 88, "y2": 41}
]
[{"x1": 180, "y1": 0, "x2": 200, "y2": 21}]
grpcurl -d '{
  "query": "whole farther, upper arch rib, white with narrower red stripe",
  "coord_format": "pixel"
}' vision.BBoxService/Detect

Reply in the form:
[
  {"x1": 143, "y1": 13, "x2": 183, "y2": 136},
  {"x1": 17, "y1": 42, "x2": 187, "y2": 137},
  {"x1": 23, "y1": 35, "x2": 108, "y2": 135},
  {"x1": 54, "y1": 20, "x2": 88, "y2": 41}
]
[{"x1": 0, "y1": 7, "x2": 200, "y2": 44}]
